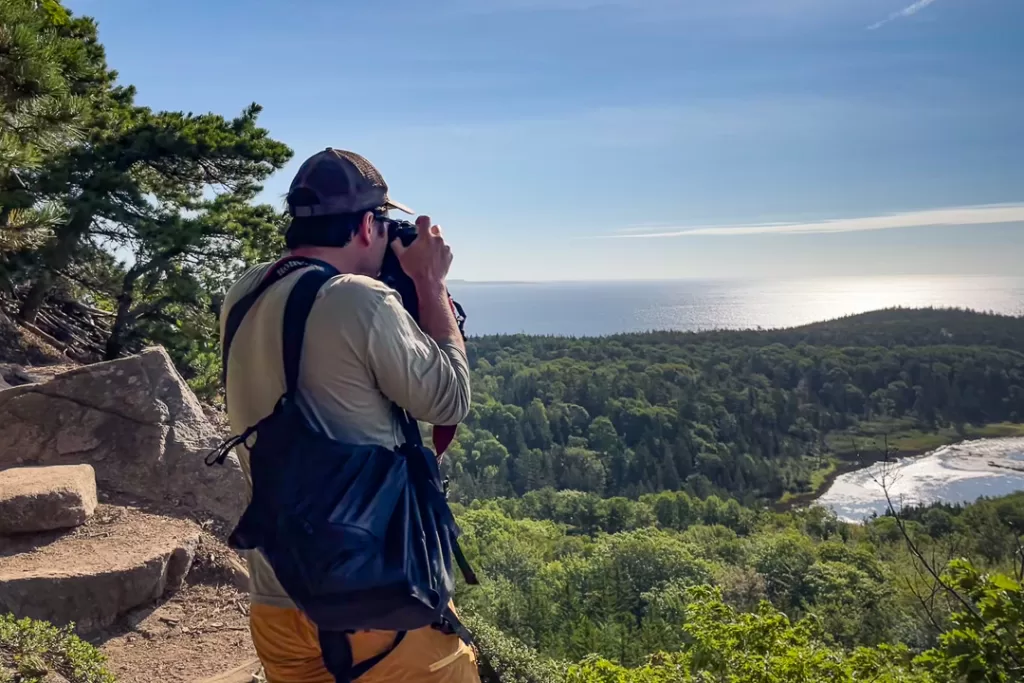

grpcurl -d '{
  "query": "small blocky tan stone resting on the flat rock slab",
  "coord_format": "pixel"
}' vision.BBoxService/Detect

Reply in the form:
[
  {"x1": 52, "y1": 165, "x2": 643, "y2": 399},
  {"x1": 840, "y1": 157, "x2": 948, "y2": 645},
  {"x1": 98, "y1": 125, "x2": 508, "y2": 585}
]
[{"x1": 0, "y1": 465, "x2": 96, "y2": 535}]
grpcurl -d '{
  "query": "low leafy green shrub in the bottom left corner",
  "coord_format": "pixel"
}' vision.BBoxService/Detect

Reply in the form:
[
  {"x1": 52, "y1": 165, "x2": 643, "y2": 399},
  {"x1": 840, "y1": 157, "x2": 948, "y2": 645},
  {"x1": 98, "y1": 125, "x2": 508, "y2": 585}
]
[{"x1": 0, "y1": 614, "x2": 114, "y2": 683}]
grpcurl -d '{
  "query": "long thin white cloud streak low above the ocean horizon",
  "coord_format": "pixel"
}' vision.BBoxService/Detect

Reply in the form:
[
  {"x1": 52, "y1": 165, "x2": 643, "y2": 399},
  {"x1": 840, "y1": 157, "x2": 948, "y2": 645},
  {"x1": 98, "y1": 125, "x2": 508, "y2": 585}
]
[{"x1": 605, "y1": 203, "x2": 1024, "y2": 240}]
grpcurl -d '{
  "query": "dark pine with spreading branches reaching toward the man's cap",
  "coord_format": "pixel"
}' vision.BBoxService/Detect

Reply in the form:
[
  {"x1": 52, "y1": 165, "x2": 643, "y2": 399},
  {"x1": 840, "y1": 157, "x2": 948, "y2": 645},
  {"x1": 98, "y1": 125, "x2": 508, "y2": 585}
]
[{"x1": 20, "y1": 98, "x2": 292, "y2": 322}]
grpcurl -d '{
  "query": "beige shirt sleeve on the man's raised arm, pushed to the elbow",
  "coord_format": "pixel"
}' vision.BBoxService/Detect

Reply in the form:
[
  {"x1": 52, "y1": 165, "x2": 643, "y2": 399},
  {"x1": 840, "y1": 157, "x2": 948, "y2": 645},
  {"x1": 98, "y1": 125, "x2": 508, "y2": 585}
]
[{"x1": 367, "y1": 294, "x2": 470, "y2": 425}]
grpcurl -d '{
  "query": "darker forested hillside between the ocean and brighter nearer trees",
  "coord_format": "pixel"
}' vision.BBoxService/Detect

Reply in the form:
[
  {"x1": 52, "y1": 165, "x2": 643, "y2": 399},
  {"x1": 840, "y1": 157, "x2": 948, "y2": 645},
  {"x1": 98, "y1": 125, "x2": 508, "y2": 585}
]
[{"x1": 449, "y1": 310, "x2": 1024, "y2": 501}]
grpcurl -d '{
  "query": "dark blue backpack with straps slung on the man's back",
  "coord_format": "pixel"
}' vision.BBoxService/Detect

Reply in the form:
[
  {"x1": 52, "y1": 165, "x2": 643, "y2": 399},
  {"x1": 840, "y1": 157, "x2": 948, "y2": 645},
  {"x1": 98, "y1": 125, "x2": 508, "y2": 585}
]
[{"x1": 207, "y1": 258, "x2": 478, "y2": 681}]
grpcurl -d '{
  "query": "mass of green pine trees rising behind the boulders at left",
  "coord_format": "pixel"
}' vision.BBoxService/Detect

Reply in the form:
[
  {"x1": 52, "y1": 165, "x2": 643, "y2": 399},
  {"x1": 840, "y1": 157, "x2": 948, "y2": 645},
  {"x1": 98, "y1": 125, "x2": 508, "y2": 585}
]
[{"x1": 0, "y1": 0, "x2": 292, "y2": 382}]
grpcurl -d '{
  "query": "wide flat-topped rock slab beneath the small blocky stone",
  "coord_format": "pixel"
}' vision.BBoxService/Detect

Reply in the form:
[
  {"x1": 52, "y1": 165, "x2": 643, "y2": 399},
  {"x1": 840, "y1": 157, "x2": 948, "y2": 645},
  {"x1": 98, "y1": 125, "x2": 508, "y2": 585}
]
[{"x1": 0, "y1": 506, "x2": 200, "y2": 633}]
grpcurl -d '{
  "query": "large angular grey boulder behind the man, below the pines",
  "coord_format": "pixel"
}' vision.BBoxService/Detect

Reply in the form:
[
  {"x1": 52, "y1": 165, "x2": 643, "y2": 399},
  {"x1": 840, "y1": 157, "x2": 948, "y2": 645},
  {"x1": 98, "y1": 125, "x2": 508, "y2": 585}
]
[{"x1": 0, "y1": 347, "x2": 245, "y2": 522}]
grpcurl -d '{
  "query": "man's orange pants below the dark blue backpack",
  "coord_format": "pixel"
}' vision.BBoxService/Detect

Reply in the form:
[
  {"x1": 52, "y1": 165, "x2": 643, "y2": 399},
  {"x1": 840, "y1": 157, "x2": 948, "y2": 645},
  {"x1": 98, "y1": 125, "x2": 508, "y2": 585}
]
[{"x1": 249, "y1": 603, "x2": 480, "y2": 683}]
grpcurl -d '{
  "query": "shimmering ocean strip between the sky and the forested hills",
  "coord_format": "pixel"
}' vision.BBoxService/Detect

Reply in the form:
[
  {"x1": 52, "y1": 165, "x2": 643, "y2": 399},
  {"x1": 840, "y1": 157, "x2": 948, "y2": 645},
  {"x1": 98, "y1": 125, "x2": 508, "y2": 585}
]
[{"x1": 449, "y1": 275, "x2": 1024, "y2": 337}]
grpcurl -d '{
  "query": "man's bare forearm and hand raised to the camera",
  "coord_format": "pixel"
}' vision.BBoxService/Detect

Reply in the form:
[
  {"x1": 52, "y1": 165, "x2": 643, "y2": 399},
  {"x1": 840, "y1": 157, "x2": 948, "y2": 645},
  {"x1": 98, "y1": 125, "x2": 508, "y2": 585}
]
[{"x1": 392, "y1": 216, "x2": 466, "y2": 353}]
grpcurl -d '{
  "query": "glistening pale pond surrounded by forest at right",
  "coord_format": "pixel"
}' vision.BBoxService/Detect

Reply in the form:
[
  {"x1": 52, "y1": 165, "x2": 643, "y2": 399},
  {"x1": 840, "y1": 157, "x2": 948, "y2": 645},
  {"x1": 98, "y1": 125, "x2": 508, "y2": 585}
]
[{"x1": 815, "y1": 437, "x2": 1024, "y2": 522}]
